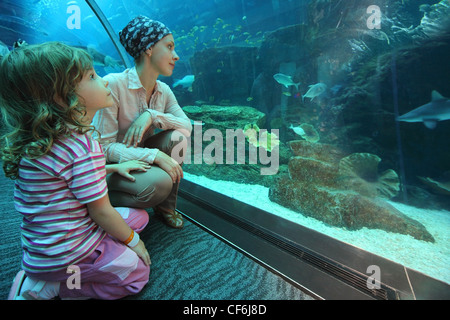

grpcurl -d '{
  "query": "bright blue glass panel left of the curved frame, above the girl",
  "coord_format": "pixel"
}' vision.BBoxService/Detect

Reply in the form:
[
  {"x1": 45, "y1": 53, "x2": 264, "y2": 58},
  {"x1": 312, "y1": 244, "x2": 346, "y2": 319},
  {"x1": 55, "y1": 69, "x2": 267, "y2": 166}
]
[{"x1": 0, "y1": 0, "x2": 124, "y2": 75}]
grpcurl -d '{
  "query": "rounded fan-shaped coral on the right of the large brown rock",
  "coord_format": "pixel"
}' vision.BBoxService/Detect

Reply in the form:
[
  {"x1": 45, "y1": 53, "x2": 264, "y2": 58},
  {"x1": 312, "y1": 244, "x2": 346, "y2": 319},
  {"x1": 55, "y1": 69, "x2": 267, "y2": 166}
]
[{"x1": 338, "y1": 153, "x2": 400, "y2": 199}]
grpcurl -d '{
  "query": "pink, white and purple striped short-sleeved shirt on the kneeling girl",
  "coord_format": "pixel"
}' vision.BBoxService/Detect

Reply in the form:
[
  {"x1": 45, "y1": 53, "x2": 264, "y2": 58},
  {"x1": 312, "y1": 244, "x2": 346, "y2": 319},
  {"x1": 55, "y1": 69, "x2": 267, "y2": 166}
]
[{"x1": 14, "y1": 132, "x2": 108, "y2": 272}]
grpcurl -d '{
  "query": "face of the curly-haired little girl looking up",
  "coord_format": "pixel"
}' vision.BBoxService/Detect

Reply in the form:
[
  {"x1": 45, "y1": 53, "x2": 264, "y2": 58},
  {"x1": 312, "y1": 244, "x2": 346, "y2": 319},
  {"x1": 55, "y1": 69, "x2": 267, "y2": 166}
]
[{"x1": 75, "y1": 69, "x2": 114, "y2": 120}]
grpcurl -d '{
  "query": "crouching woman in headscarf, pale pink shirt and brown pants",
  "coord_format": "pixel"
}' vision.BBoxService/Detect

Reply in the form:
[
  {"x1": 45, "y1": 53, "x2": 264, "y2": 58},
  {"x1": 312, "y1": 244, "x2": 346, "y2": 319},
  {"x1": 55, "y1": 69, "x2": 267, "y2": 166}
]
[{"x1": 92, "y1": 16, "x2": 192, "y2": 228}]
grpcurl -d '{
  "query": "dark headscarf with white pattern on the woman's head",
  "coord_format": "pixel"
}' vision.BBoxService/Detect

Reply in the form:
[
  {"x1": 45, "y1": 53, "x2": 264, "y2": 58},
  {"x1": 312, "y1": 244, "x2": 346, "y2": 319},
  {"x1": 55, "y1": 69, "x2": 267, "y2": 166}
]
[{"x1": 119, "y1": 16, "x2": 172, "y2": 59}]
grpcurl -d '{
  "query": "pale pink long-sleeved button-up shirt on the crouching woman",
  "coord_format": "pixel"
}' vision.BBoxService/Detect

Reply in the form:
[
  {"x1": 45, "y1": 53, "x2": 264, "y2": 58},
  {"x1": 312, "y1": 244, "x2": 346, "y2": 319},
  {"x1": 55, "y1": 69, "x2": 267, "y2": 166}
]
[{"x1": 92, "y1": 67, "x2": 192, "y2": 163}]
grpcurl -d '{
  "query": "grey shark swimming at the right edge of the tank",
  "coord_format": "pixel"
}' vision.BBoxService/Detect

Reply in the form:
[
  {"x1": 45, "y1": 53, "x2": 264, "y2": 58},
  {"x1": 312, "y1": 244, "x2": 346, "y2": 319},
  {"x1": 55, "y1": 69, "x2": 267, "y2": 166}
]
[{"x1": 396, "y1": 90, "x2": 450, "y2": 129}]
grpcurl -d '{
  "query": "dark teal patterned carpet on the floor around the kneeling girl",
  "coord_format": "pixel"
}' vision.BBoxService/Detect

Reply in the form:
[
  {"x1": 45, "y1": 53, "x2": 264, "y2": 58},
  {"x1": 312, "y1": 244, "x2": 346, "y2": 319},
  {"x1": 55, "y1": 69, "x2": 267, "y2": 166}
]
[{"x1": 0, "y1": 172, "x2": 312, "y2": 300}]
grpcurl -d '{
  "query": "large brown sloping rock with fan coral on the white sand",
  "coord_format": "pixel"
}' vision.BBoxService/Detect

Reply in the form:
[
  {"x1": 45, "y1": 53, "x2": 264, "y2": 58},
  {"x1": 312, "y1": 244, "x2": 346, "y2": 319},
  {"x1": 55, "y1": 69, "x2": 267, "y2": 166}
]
[{"x1": 269, "y1": 140, "x2": 435, "y2": 242}]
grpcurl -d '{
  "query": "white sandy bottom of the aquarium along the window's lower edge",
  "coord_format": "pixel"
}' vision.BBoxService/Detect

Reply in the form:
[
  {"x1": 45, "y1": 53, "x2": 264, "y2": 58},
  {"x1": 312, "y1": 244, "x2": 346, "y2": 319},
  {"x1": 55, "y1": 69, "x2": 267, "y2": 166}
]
[{"x1": 184, "y1": 172, "x2": 450, "y2": 284}]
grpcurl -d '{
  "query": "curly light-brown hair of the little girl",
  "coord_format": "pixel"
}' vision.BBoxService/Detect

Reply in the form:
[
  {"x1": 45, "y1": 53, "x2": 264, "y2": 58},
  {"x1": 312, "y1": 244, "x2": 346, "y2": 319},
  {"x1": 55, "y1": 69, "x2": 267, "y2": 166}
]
[{"x1": 0, "y1": 42, "x2": 93, "y2": 179}]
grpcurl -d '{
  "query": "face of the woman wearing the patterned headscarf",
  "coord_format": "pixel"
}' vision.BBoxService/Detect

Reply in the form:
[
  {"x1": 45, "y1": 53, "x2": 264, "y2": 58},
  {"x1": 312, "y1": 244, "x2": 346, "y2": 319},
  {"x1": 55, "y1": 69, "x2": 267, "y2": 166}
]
[{"x1": 150, "y1": 34, "x2": 180, "y2": 77}]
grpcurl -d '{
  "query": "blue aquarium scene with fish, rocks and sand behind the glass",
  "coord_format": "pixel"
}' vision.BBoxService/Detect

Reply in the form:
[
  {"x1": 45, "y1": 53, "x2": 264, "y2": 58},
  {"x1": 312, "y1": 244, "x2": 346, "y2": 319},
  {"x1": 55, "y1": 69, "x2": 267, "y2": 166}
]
[{"x1": 0, "y1": 0, "x2": 450, "y2": 283}]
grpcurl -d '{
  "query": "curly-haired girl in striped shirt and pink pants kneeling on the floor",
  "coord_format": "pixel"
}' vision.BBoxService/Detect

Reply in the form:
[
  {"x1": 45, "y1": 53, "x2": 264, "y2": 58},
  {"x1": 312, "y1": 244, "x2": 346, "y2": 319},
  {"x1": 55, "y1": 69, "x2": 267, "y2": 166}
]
[{"x1": 0, "y1": 42, "x2": 150, "y2": 299}]
